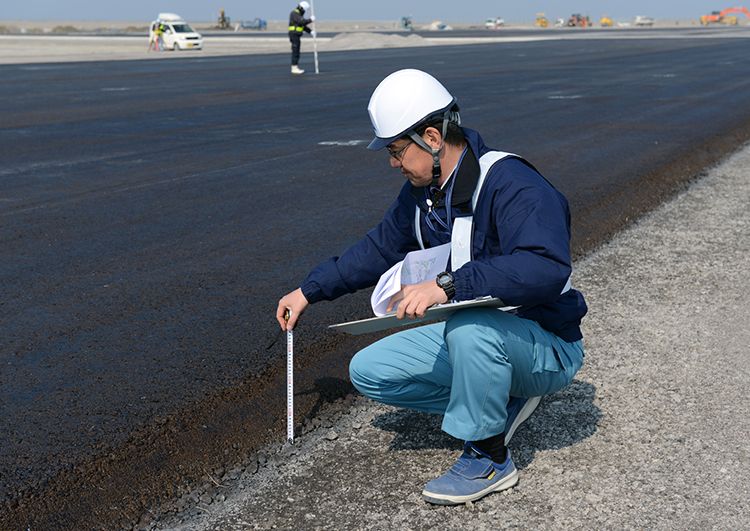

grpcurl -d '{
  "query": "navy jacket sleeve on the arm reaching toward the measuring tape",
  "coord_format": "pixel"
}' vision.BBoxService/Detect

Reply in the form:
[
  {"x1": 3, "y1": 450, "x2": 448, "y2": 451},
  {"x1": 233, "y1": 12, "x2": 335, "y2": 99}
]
[{"x1": 300, "y1": 183, "x2": 418, "y2": 303}]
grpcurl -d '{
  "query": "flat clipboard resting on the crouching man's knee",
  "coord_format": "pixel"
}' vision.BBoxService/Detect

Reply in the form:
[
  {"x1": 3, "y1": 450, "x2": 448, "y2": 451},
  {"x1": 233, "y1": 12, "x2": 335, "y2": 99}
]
[{"x1": 328, "y1": 296, "x2": 518, "y2": 336}]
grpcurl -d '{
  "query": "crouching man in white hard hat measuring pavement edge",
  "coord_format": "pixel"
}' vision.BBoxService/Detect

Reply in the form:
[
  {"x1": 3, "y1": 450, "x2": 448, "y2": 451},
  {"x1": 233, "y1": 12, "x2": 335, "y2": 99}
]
[{"x1": 276, "y1": 69, "x2": 586, "y2": 505}]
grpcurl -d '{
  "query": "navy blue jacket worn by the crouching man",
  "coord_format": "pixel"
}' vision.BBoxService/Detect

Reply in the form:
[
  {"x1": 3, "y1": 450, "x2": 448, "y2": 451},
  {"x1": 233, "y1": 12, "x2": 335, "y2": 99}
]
[{"x1": 300, "y1": 128, "x2": 586, "y2": 341}]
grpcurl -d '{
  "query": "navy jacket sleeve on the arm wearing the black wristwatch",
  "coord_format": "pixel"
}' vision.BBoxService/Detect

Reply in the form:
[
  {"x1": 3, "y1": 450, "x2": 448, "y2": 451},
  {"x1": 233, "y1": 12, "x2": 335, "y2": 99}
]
[{"x1": 454, "y1": 159, "x2": 572, "y2": 306}]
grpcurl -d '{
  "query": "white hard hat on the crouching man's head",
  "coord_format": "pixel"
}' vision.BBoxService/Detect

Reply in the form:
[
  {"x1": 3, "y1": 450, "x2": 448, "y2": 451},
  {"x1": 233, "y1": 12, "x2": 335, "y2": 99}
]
[{"x1": 367, "y1": 68, "x2": 456, "y2": 150}]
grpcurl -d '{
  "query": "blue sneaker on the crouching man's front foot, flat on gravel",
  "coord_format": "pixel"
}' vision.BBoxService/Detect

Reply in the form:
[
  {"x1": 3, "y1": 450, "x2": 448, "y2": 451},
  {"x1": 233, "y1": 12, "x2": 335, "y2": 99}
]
[{"x1": 422, "y1": 442, "x2": 518, "y2": 505}]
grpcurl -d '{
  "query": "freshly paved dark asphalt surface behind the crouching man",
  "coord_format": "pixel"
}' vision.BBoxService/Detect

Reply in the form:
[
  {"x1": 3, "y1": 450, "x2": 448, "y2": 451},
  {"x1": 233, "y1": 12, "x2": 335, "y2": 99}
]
[{"x1": 0, "y1": 32, "x2": 750, "y2": 529}]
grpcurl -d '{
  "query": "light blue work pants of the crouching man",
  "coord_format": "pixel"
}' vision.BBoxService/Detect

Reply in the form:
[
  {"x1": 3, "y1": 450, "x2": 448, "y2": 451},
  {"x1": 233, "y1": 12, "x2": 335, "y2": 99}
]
[{"x1": 349, "y1": 308, "x2": 583, "y2": 441}]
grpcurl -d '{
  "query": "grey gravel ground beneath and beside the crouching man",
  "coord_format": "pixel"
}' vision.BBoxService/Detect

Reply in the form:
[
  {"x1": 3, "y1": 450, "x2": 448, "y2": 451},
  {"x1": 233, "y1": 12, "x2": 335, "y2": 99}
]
[{"x1": 140, "y1": 147, "x2": 750, "y2": 530}]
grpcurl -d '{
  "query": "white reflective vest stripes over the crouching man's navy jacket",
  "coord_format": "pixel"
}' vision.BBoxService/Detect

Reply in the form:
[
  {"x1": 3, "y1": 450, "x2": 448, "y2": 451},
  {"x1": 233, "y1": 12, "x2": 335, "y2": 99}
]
[{"x1": 414, "y1": 151, "x2": 571, "y2": 295}]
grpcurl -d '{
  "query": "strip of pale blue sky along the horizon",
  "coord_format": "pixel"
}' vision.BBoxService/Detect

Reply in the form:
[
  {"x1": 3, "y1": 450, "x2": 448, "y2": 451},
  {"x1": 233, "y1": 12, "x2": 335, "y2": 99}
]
[{"x1": 0, "y1": 0, "x2": 728, "y2": 23}]
